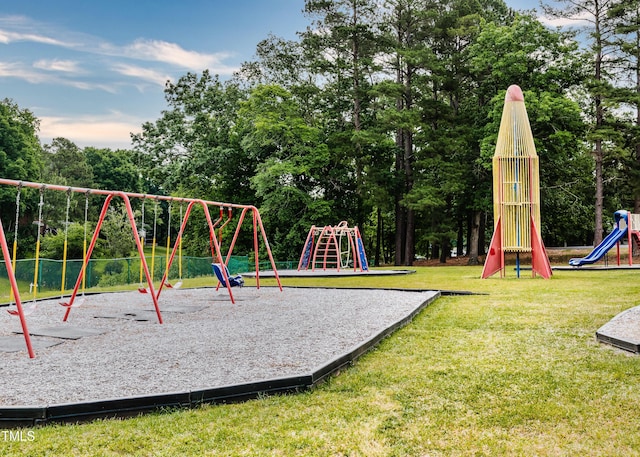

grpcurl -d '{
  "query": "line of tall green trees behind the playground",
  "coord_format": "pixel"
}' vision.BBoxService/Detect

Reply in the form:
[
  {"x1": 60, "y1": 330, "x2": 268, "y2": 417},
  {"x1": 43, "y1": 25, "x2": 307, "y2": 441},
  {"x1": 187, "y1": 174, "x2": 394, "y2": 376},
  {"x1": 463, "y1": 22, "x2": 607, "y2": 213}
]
[{"x1": 0, "y1": 0, "x2": 640, "y2": 265}]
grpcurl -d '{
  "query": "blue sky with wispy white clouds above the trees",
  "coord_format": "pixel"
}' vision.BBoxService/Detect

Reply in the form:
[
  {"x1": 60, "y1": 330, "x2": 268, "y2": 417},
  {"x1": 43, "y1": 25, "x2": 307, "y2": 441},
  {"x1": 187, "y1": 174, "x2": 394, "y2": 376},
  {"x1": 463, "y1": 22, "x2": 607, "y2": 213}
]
[{"x1": 0, "y1": 0, "x2": 560, "y2": 149}]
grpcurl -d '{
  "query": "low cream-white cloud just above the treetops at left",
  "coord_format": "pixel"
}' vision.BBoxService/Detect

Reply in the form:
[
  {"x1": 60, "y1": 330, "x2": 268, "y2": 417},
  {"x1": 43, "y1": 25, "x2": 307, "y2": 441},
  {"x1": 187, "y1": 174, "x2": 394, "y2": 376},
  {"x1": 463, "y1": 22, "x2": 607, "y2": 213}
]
[{"x1": 38, "y1": 112, "x2": 144, "y2": 149}]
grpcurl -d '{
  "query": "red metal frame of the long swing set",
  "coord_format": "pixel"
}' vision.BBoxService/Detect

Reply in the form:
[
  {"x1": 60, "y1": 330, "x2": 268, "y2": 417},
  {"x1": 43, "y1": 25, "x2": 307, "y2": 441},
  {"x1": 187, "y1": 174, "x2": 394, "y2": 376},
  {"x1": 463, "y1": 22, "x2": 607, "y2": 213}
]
[{"x1": 0, "y1": 178, "x2": 282, "y2": 358}]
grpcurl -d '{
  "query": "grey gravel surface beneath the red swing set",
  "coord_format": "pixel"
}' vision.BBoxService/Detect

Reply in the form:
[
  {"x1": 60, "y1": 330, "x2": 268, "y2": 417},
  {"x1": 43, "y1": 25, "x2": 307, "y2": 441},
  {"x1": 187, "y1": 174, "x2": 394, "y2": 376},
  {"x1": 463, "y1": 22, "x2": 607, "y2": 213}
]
[{"x1": 0, "y1": 287, "x2": 436, "y2": 407}]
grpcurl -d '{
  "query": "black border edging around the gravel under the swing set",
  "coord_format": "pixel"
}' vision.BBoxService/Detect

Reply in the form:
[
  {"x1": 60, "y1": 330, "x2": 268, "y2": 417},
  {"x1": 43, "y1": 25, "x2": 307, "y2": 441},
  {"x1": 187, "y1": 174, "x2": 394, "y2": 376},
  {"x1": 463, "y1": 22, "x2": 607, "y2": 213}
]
[{"x1": 0, "y1": 289, "x2": 441, "y2": 429}]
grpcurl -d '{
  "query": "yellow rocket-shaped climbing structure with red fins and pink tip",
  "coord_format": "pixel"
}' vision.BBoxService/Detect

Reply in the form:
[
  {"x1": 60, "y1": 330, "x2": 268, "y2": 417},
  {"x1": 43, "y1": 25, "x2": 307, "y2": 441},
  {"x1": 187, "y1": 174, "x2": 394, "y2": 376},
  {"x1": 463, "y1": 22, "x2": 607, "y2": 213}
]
[{"x1": 482, "y1": 85, "x2": 551, "y2": 279}]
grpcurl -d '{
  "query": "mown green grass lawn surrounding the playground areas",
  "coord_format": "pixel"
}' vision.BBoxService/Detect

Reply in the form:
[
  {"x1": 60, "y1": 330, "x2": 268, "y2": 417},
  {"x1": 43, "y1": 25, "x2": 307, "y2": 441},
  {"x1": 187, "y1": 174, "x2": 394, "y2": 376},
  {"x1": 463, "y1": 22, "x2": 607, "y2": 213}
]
[{"x1": 0, "y1": 267, "x2": 640, "y2": 456}]
